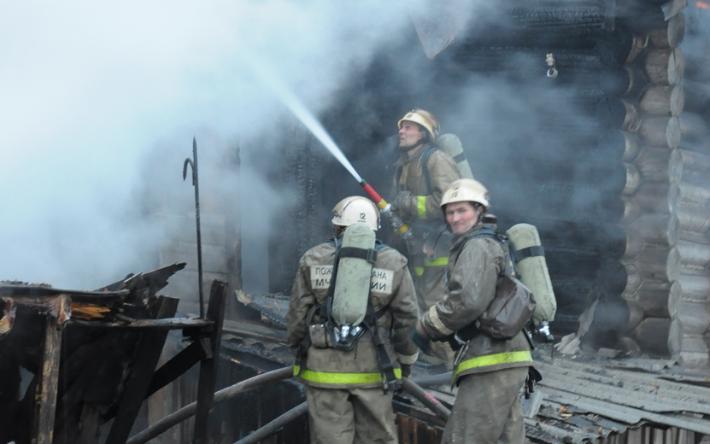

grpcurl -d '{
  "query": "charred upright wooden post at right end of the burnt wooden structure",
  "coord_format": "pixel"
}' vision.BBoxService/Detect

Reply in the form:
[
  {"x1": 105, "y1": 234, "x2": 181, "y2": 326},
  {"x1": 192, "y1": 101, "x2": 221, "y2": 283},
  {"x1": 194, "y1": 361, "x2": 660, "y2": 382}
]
[{"x1": 193, "y1": 280, "x2": 226, "y2": 444}]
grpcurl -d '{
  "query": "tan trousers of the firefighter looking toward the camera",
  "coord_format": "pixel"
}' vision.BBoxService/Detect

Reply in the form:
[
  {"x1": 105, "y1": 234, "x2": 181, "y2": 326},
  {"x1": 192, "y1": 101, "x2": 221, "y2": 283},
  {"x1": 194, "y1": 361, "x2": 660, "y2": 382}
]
[{"x1": 442, "y1": 367, "x2": 528, "y2": 444}]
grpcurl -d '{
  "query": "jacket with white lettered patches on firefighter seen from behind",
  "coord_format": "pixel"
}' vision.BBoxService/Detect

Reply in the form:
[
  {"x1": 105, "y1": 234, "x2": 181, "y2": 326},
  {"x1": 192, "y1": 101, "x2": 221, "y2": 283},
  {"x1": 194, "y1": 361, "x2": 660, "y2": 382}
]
[{"x1": 286, "y1": 241, "x2": 418, "y2": 388}]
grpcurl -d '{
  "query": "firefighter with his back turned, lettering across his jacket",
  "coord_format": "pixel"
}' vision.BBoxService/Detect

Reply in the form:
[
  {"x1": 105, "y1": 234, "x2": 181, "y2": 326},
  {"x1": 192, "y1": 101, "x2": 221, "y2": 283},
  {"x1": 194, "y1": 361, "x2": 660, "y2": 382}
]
[{"x1": 286, "y1": 196, "x2": 418, "y2": 444}]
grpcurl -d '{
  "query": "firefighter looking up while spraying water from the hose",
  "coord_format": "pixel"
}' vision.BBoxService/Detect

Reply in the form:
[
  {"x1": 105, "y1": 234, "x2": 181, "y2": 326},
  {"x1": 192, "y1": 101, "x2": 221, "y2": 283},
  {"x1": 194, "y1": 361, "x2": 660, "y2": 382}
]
[{"x1": 393, "y1": 109, "x2": 461, "y2": 366}]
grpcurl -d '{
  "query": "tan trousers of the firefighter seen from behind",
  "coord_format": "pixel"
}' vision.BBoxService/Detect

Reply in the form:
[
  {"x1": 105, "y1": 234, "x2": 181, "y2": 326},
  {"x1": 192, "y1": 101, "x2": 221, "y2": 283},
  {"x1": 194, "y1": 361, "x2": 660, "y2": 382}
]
[{"x1": 306, "y1": 386, "x2": 398, "y2": 444}]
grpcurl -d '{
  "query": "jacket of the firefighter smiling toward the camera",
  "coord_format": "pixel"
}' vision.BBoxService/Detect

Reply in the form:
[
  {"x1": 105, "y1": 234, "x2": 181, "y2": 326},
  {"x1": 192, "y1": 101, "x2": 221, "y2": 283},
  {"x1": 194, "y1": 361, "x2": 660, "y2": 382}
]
[{"x1": 420, "y1": 226, "x2": 532, "y2": 380}]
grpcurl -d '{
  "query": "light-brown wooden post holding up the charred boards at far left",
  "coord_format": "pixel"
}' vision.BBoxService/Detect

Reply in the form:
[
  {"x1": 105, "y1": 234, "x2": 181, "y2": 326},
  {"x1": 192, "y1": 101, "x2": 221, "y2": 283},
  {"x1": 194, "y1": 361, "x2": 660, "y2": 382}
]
[{"x1": 32, "y1": 295, "x2": 67, "y2": 444}]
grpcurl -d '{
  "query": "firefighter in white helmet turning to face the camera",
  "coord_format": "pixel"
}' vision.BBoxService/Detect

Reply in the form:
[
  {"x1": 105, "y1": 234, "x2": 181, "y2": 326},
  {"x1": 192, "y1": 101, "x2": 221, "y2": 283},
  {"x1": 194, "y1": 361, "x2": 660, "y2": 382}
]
[{"x1": 416, "y1": 179, "x2": 532, "y2": 444}]
